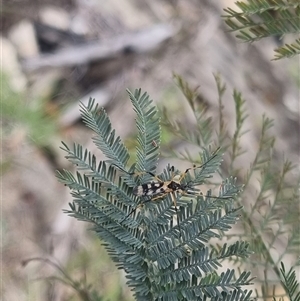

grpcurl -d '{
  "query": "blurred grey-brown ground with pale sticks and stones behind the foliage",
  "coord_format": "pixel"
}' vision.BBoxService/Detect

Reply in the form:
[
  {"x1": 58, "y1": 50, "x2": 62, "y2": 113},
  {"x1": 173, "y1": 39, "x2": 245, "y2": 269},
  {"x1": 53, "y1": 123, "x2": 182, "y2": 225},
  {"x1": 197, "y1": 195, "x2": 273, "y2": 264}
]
[{"x1": 1, "y1": 0, "x2": 300, "y2": 301}]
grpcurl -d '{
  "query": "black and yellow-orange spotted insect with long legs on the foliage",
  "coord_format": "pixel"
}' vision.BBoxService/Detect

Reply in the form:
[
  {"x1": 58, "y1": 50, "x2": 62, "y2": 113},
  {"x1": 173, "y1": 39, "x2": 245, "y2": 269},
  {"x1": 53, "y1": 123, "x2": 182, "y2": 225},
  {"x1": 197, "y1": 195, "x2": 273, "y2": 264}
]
[{"x1": 112, "y1": 148, "x2": 223, "y2": 236}]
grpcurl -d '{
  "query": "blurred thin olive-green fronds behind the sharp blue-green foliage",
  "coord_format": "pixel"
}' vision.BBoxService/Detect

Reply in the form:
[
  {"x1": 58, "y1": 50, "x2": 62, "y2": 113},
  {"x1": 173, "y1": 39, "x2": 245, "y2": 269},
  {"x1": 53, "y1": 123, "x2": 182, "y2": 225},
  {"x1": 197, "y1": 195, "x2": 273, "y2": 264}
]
[{"x1": 164, "y1": 75, "x2": 300, "y2": 299}]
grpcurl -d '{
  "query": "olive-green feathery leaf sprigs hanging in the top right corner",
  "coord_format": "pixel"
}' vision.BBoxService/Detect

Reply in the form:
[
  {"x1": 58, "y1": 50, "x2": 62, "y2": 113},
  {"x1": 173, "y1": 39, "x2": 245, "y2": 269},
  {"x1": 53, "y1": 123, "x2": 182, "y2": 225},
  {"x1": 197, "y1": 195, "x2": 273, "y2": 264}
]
[{"x1": 223, "y1": 0, "x2": 300, "y2": 59}]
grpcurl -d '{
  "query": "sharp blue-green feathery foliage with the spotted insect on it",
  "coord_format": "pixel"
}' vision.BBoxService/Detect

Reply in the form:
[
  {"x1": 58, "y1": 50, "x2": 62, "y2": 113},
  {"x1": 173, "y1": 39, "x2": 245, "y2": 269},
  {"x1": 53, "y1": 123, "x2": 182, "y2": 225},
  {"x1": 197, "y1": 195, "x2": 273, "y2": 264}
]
[{"x1": 57, "y1": 90, "x2": 253, "y2": 301}]
